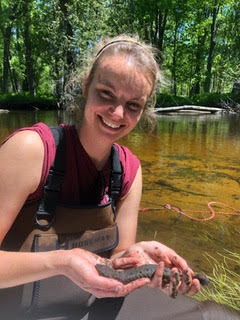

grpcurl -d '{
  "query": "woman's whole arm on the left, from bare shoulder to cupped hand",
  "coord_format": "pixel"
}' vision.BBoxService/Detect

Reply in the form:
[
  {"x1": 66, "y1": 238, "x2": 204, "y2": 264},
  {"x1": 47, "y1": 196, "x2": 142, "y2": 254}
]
[{"x1": 0, "y1": 131, "x2": 146, "y2": 297}]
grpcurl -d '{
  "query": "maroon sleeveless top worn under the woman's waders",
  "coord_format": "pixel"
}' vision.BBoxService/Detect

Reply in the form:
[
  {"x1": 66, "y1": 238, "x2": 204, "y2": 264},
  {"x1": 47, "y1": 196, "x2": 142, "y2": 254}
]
[{"x1": 2, "y1": 123, "x2": 140, "y2": 205}]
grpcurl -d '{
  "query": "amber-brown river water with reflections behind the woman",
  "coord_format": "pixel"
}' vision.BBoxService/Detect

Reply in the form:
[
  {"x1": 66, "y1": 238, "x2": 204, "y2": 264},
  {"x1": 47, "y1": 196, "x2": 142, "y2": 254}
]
[{"x1": 0, "y1": 112, "x2": 240, "y2": 272}]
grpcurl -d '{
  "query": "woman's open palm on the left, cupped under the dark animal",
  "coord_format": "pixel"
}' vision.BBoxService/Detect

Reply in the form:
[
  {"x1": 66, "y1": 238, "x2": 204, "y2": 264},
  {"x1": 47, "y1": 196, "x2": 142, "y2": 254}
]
[{"x1": 61, "y1": 249, "x2": 150, "y2": 298}]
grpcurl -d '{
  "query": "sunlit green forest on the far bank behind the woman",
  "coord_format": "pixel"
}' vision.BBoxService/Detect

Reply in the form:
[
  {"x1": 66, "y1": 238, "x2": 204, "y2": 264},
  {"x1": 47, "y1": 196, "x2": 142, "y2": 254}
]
[{"x1": 0, "y1": 0, "x2": 240, "y2": 109}]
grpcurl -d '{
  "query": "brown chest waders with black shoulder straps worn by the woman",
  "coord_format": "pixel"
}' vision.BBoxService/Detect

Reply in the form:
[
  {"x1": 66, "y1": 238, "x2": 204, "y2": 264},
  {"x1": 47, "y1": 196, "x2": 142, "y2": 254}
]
[{"x1": 0, "y1": 127, "x2": 122, "y2": 320}]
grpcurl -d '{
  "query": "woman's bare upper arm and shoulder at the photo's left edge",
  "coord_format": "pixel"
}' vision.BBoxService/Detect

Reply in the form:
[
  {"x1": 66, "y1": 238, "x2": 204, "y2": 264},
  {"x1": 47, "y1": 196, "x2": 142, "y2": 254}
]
[{"x1": 0, "y1": 131, "x2": 44, "y2": 244}]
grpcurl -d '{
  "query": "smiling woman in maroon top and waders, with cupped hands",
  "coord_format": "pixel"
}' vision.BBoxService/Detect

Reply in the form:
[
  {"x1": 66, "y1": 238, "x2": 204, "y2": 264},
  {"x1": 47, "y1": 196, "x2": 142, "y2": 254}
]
[{"x1": 0, "y1": 37, "x2": 200, "y2": 319}]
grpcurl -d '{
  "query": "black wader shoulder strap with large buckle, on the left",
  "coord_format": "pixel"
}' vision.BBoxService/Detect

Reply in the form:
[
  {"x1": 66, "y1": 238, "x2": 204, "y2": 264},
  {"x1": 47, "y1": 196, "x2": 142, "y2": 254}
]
[{"x1": 35, "y1": 127, "x2": 65, "y2": 230}]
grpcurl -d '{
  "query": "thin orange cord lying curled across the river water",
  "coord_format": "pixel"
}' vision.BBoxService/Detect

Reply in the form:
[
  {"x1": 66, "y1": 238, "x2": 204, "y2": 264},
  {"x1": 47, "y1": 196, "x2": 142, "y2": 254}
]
[{"x1": 139, "y1": 201, "x2": 240, "y2": 222}]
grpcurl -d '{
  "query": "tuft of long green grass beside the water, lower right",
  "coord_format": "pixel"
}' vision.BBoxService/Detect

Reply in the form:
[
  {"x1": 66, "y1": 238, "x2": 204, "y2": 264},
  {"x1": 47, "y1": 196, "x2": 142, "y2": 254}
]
[{"x1": 196, "y1": 251, "x2": 240, "y2": 311}]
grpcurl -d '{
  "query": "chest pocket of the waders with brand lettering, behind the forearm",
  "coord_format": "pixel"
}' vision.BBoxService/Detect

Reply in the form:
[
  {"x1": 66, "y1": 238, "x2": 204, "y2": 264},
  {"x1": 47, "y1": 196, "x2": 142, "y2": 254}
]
[{"x1": 23, "y1": 225, "x2": 118, "y2": 313}]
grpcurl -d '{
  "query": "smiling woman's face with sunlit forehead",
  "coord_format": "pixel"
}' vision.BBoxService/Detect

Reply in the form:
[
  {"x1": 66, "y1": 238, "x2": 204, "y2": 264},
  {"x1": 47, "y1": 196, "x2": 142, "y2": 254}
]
[{"x1": 82, "y1": 55, "x2": 152, "y2": 143}]
